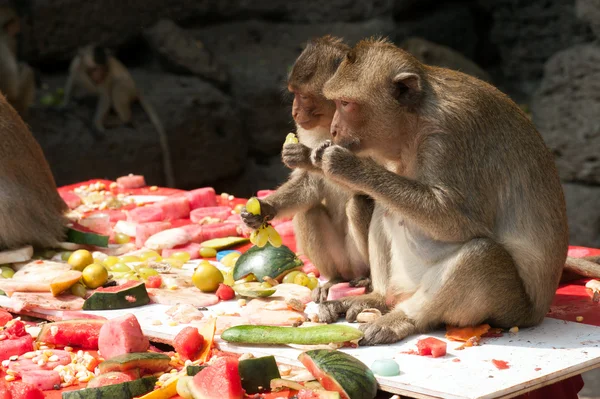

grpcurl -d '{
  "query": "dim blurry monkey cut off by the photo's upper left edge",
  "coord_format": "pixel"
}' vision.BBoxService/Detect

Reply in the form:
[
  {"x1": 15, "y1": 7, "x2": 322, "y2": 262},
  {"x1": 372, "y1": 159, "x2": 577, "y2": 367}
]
[{"x1": 0, "y1": 6, "x2": 35, "y2": 117}]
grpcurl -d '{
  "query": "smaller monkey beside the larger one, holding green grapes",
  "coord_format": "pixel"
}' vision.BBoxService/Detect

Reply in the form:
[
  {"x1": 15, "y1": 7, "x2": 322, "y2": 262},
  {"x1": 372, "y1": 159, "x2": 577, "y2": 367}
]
[{"x1": 242, "y1": 36, "x2": 373, "y2": 302}]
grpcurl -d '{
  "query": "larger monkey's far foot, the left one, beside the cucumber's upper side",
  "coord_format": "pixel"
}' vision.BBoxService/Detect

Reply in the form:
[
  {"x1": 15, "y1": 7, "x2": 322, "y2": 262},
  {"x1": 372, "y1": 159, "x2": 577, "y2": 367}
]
[{"x1": 319, "y1": 292, "x2": 389, "y2": 323}]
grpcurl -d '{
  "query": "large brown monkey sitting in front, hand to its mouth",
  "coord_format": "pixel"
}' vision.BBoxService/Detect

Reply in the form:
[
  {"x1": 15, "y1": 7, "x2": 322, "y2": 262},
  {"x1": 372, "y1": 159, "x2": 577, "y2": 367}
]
[{"x1": 312, "y1": 36, "x2": 568, "y2": 344}]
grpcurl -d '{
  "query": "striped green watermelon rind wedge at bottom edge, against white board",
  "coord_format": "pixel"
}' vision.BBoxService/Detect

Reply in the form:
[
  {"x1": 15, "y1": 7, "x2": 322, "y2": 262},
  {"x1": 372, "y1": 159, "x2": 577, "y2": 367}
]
[{"x1": 298, "y1": 349, "x2": 377, "y2": 399}]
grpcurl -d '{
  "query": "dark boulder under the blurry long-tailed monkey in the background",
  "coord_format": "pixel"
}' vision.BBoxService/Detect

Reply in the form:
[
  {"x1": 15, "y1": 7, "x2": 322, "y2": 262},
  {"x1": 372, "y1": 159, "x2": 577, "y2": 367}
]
[{"x1": 27, "y1": 70, "x2": 247, "y2": 189}]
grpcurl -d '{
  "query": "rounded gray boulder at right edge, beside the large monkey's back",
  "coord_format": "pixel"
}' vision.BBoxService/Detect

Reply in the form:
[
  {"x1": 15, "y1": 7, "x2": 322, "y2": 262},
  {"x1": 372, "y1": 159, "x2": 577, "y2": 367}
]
[{"x1": 531, "y1": 44, "x2": 600, "y2": 184}]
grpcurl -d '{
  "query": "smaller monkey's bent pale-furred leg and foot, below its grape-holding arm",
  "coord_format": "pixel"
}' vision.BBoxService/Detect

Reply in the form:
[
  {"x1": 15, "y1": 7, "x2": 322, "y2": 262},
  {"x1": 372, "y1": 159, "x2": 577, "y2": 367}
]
[{"x1": 294, "y1": 205, "x2": 351, "y2": 303}]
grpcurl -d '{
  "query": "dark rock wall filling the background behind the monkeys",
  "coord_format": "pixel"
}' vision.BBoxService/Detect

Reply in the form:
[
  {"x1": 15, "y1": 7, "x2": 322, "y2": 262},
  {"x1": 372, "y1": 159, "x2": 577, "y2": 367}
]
[{"x1": 0, "y1": 0, "x2": 600, "y2": 245}]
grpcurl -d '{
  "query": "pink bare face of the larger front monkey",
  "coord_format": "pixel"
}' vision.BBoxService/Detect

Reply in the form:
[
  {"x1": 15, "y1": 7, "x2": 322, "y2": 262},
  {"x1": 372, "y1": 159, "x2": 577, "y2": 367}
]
[{"x1": 331, "y1": 100, "x2": 365, "y2": 152}]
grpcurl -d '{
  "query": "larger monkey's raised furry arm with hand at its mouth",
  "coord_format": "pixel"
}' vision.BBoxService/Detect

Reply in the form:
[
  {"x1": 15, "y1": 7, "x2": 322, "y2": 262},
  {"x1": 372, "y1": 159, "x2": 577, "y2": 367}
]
[{"x1": 314, "y1": 145, "x2": 482, "y2": 241}]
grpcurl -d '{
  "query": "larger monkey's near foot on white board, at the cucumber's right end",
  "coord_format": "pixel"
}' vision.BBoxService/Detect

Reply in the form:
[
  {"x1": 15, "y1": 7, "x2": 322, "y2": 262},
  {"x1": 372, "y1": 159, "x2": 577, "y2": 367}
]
[{"x1": 358, "y1": 312, "x2": 417, "y2": 346}]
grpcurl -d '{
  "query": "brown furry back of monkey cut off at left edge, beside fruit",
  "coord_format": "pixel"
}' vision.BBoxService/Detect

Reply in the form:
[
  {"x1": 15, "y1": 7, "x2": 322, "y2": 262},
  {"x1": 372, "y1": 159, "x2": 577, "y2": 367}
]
[{"x1": 0, "y1": 94, "x2": 67, "y2": 250}]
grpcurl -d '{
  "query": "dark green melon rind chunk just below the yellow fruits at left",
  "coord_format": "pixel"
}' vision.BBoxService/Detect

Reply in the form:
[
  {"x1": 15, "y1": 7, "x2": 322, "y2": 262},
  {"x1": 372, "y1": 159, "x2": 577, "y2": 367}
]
[{"x1": 83, "y1": 281, "x2": 150, "y2": 310}]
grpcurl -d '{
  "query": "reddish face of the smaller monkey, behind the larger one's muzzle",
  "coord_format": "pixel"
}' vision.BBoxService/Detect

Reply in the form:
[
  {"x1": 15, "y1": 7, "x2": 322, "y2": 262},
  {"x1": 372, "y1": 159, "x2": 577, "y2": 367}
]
[{"x1": 292, "y1": 91, "x2": 335, "y2": 130}]
